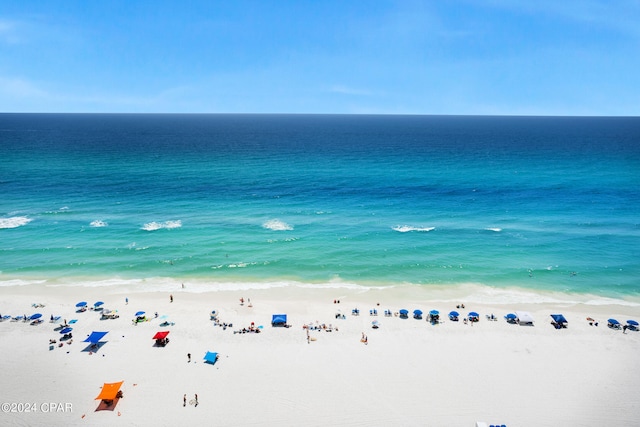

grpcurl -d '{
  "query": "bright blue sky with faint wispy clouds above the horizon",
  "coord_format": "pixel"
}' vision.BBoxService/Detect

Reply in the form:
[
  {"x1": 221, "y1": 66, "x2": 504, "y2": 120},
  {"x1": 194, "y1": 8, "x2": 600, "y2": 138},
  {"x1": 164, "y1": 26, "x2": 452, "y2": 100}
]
[{"x1": 0, "y1": 0, "x2": 640, "y2": 116}]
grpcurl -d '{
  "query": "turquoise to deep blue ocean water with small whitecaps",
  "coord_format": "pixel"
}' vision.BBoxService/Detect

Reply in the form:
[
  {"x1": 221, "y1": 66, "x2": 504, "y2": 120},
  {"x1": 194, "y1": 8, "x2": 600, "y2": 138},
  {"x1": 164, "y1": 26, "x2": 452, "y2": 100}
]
[{"x1": 0, "y1": 114, "x2": 640, "y2": 297}]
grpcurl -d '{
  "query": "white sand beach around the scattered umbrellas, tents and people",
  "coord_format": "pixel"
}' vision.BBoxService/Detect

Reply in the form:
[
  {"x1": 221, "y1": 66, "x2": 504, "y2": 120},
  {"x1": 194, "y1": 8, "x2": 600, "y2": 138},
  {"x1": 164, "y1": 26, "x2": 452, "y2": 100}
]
[{"x1": 0, "y1": 281, "x2": 640, "y2": 427}]
